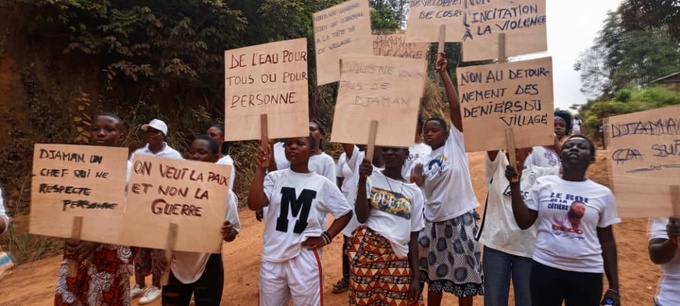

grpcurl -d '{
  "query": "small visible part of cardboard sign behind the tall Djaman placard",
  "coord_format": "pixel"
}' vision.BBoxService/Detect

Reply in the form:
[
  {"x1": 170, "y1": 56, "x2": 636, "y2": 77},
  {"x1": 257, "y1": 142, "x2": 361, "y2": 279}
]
[{"x1": 373, "y1": 33, "x2": 430, "y2": 60}]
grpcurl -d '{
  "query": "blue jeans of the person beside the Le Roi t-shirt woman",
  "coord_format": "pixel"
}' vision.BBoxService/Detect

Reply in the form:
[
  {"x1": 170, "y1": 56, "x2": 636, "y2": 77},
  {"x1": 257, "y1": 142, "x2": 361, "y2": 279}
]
[{"x1": 482, "y1": 246, "x2": 532, "y2": 306}]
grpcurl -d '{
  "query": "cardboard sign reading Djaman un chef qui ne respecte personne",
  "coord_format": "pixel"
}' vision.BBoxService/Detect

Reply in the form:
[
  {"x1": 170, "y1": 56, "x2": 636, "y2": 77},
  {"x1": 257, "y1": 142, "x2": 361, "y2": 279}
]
[{"x1": 29, "y1": 144, "x2": 128, "y2": 243}]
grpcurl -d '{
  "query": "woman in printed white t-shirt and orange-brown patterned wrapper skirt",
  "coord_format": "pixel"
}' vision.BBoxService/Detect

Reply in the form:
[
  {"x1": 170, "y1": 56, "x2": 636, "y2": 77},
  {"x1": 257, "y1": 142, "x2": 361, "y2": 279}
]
[{"x1": 348, "y1": 147, "x2": 424, "y2": 305}]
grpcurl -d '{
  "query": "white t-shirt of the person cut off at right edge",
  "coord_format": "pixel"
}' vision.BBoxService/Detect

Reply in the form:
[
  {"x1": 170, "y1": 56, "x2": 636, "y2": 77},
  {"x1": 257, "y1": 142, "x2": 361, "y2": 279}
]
[{"x1": 649, "y1": 218, "x2": 680, "y2": 306}]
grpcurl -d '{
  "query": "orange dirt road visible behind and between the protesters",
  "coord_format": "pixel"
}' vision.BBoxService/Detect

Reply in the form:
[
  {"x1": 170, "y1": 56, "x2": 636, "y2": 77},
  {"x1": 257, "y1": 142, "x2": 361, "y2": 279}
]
[{"x1": 0, "y1": 153, "x2": 659, "y2": 306}]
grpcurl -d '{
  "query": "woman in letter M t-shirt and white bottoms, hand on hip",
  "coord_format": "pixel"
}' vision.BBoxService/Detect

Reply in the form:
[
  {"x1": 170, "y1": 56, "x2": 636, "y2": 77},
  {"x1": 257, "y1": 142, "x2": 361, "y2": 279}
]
[{"x1": 248, "y1": 136, "x2": 352, "y2": 306}]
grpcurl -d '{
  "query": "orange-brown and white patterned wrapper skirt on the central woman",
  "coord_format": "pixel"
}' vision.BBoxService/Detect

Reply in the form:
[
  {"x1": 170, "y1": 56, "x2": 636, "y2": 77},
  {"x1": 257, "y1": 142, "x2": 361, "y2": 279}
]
[{"x1": 347, "y1": 226, "x2": 423, "y2": 306}]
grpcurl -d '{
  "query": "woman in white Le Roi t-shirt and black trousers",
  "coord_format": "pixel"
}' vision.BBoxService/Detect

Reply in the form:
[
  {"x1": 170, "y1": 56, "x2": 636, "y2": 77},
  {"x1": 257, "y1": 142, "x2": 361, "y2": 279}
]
[{"x1": 506, "y1": 135, "x2": 621, "y2": 306}]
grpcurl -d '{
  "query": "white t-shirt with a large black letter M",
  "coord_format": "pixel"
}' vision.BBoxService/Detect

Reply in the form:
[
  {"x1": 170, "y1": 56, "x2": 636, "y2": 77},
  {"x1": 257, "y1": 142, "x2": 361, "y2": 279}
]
[{"x1": 262, "y1": 168, "x2": 352, "y2": 262}]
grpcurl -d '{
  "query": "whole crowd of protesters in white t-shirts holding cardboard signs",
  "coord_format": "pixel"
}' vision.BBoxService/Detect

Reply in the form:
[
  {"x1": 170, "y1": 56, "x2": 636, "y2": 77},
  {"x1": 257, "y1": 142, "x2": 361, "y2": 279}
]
[{"x1": 0, "y1": 56, "x2": 680, "y2": 306}]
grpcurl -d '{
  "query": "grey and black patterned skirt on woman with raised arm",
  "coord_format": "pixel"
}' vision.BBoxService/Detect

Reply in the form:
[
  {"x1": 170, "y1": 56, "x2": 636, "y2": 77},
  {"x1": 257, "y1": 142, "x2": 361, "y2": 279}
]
[{"x1": 418, "y1": 211, "x2": 484, "y2": 297}]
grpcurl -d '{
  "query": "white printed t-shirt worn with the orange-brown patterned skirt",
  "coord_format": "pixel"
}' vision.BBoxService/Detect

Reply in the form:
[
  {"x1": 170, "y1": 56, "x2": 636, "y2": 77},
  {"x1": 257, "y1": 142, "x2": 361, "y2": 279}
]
[{"x1": 366, "y1": 172, "x2": 425, "y2": 258}]
